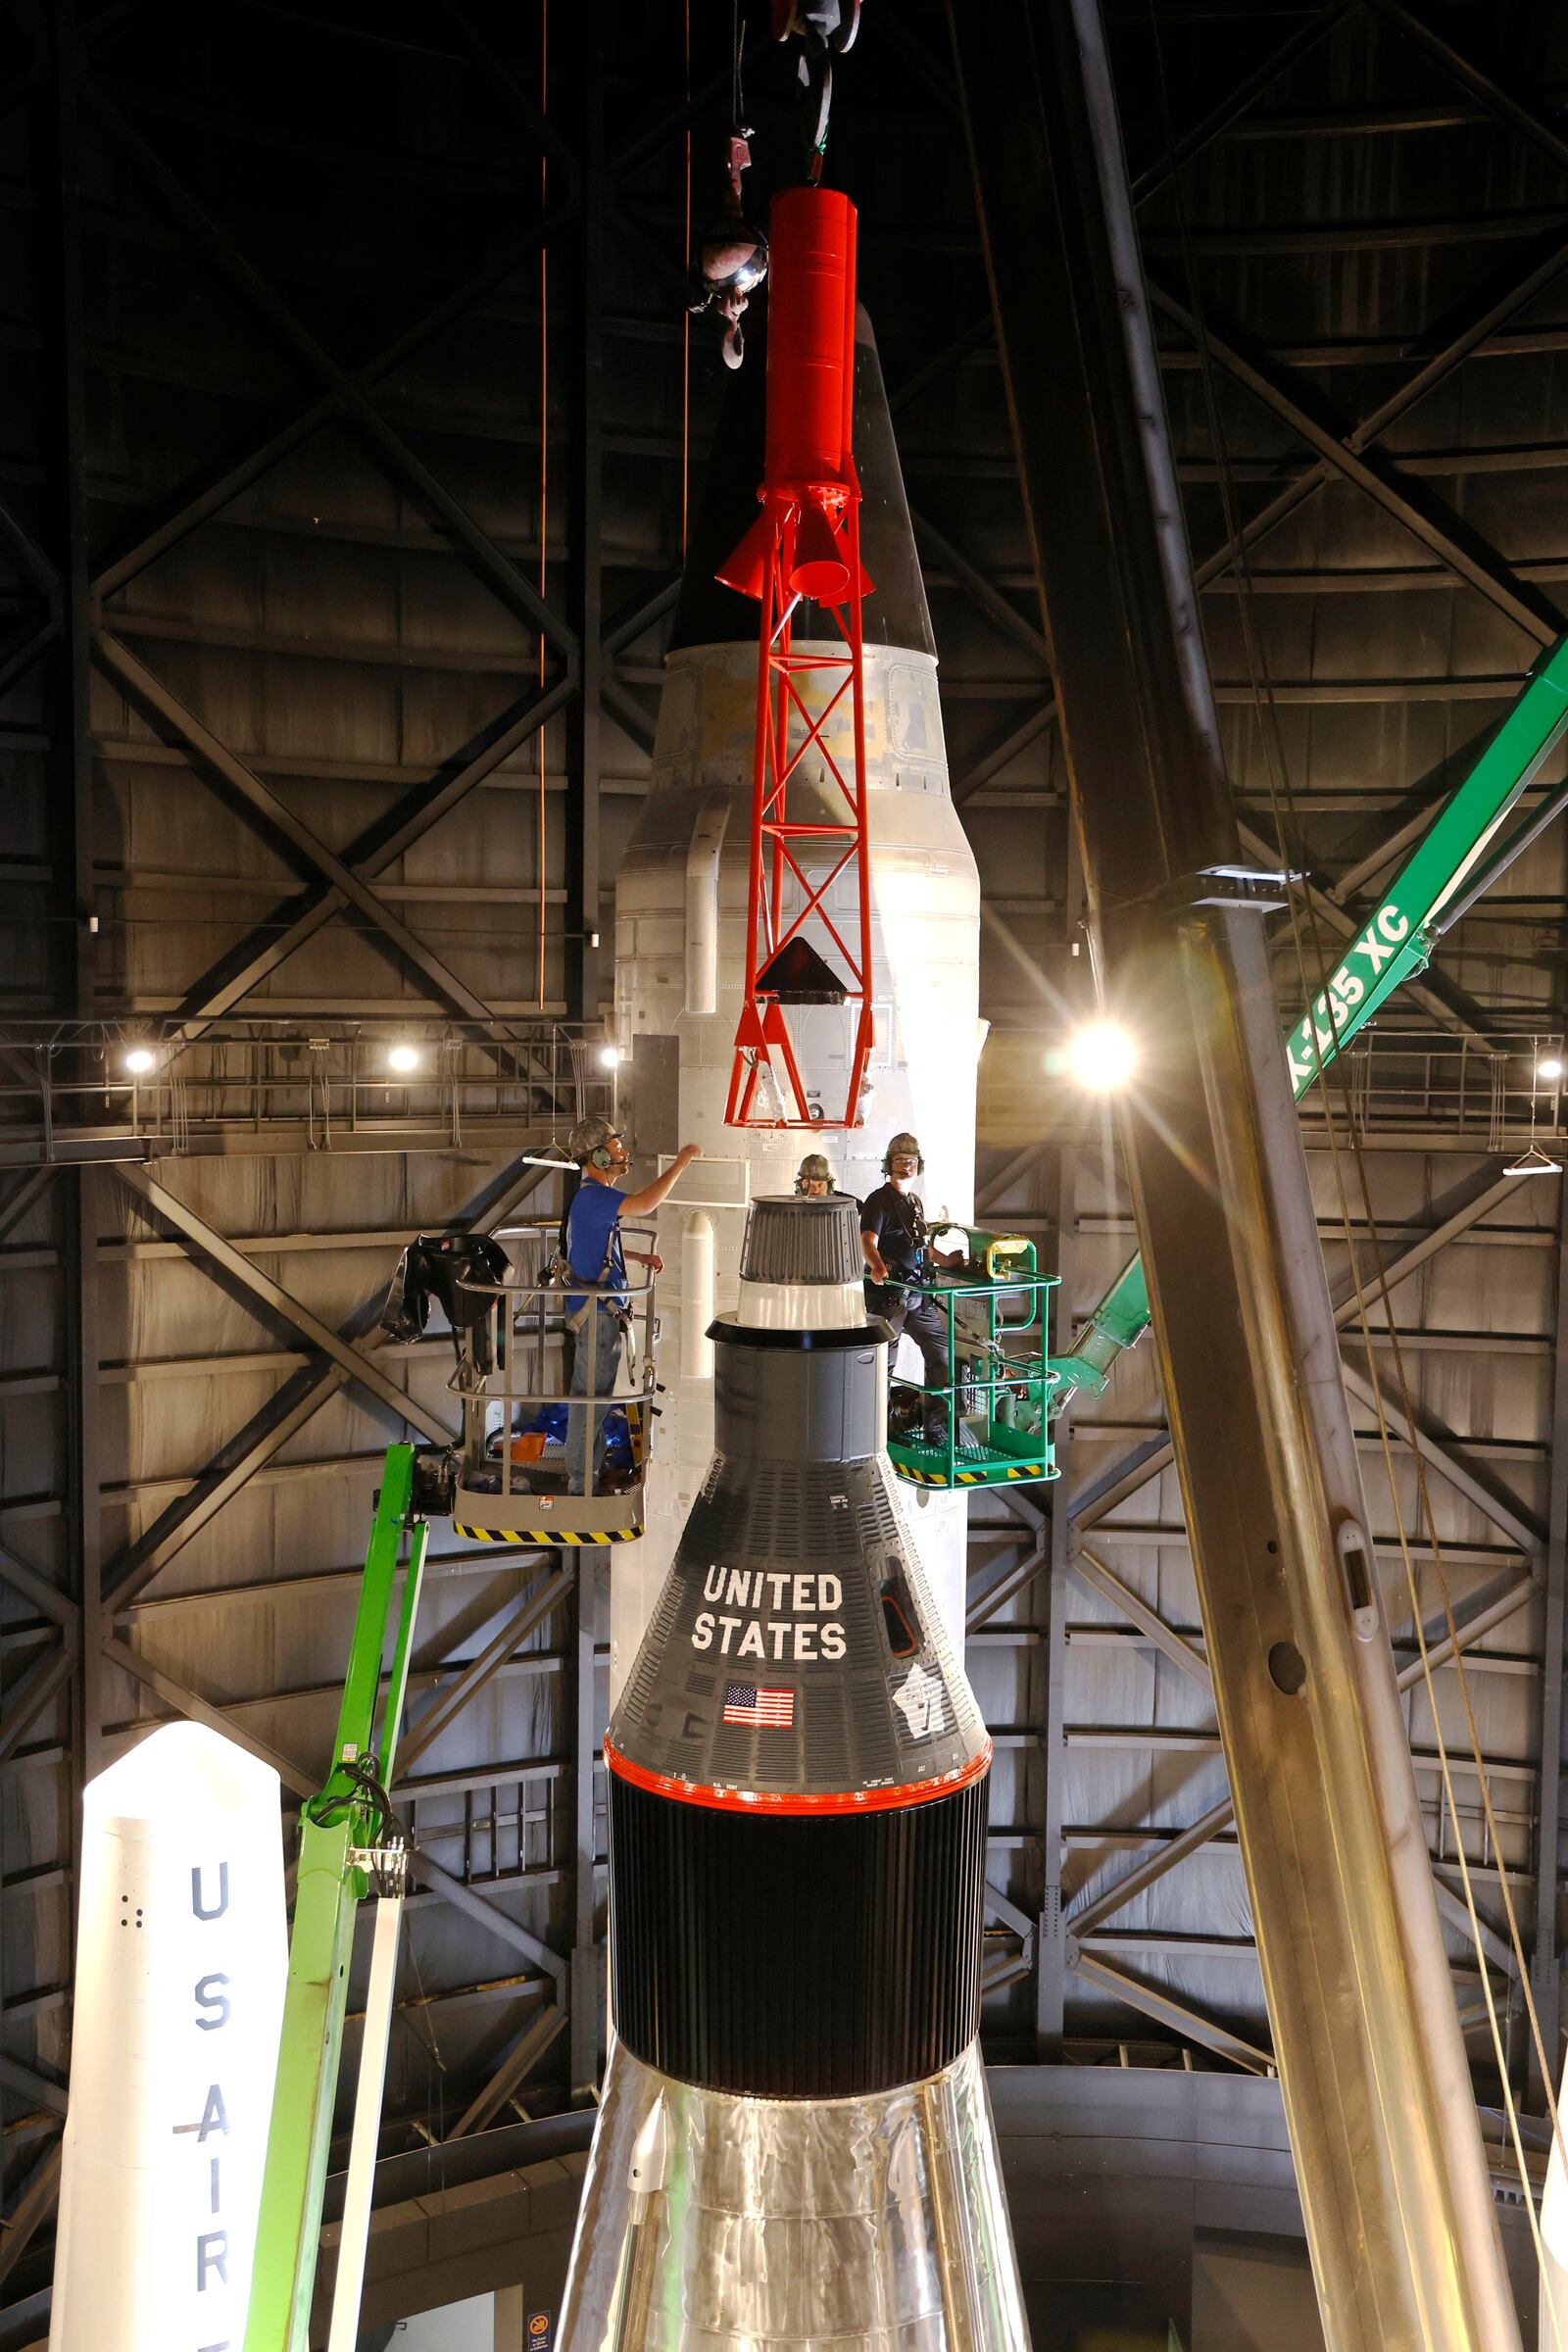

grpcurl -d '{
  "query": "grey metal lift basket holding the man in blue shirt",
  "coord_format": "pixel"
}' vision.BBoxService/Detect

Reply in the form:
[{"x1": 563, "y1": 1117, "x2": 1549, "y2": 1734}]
[{"x1": 452, "y1": 1218, "x2": 659, "y2": 1498}]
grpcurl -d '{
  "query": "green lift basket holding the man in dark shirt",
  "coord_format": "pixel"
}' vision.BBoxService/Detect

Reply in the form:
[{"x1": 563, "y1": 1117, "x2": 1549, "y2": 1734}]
[{"x1": 889, "y1": 1225, "x2": 1060, "y2": 1487}]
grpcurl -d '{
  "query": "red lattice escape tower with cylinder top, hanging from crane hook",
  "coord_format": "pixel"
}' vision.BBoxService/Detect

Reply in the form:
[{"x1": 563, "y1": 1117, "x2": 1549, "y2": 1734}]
[{"x1": 719, "y1": 188, "x2": 874, "y2": 1127}]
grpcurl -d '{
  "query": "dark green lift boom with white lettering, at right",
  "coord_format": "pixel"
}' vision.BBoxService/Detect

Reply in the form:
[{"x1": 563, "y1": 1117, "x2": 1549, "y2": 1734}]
[{"x1": 1051, "y1": 637, "x2": 1568, "y2": 1416}]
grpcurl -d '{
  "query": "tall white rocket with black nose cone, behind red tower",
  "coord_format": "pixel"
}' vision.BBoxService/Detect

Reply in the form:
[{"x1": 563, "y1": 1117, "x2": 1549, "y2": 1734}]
[{"x1": 612, "y1": 190, "x2": 983, "y2": 1700}]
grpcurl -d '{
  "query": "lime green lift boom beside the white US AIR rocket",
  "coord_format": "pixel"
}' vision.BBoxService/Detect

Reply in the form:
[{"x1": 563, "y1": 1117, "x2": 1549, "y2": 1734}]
[{"x1": 244, "y1": 1445, "x2": 428, "y2": 2352}]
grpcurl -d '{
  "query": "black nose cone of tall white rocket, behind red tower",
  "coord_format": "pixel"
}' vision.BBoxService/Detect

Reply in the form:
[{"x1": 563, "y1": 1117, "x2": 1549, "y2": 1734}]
[{"x1": 670, "y1": 308, "x2": 936, "y2": 654}]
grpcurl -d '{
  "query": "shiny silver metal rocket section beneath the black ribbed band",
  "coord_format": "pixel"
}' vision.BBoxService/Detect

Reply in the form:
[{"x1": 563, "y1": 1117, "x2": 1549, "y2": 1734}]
[{"x1": 562, "y1": 2041, "x2": 1027, "y2": 2352}]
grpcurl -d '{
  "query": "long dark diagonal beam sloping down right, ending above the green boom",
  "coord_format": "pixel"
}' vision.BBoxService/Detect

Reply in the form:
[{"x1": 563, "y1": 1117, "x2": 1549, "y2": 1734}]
[{"x1": 1145, "y1": 284, "x2": 1568, "y2": 645}]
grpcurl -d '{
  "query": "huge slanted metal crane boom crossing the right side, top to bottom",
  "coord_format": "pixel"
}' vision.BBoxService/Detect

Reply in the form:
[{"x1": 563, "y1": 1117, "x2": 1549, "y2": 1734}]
[{"x1": 948, "y1": 0, "x2": 1519, "y2": 2352}]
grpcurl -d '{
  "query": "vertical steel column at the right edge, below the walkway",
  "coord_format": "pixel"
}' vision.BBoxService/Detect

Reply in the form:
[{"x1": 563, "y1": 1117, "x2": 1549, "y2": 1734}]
[{"x1": 1526, "y1": 1186, "x2": 1568, "y2": 2115}]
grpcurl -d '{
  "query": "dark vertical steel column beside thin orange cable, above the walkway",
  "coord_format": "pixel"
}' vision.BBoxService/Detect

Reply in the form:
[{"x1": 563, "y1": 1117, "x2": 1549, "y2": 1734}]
[{"x1": 566, "y1": 41, "x2": 609, "y2": 1021}]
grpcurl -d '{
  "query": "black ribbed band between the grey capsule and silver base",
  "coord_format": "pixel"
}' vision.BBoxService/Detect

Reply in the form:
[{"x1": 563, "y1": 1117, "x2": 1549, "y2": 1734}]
[{"x1": 609, "y1": 1774, "x2": 990, "y2": 2098}]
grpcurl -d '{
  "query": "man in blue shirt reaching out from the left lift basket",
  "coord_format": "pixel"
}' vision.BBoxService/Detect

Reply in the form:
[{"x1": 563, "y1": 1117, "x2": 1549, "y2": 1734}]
[{"x1": 564, "y1": 1119, "x2": 703, "y2": 1494}]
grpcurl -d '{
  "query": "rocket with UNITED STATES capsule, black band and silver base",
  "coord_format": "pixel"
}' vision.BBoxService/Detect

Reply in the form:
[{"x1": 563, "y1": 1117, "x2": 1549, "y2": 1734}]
[{"x1": 562, "y1": 1198, "x2": 1027, "y2": 2352}]
